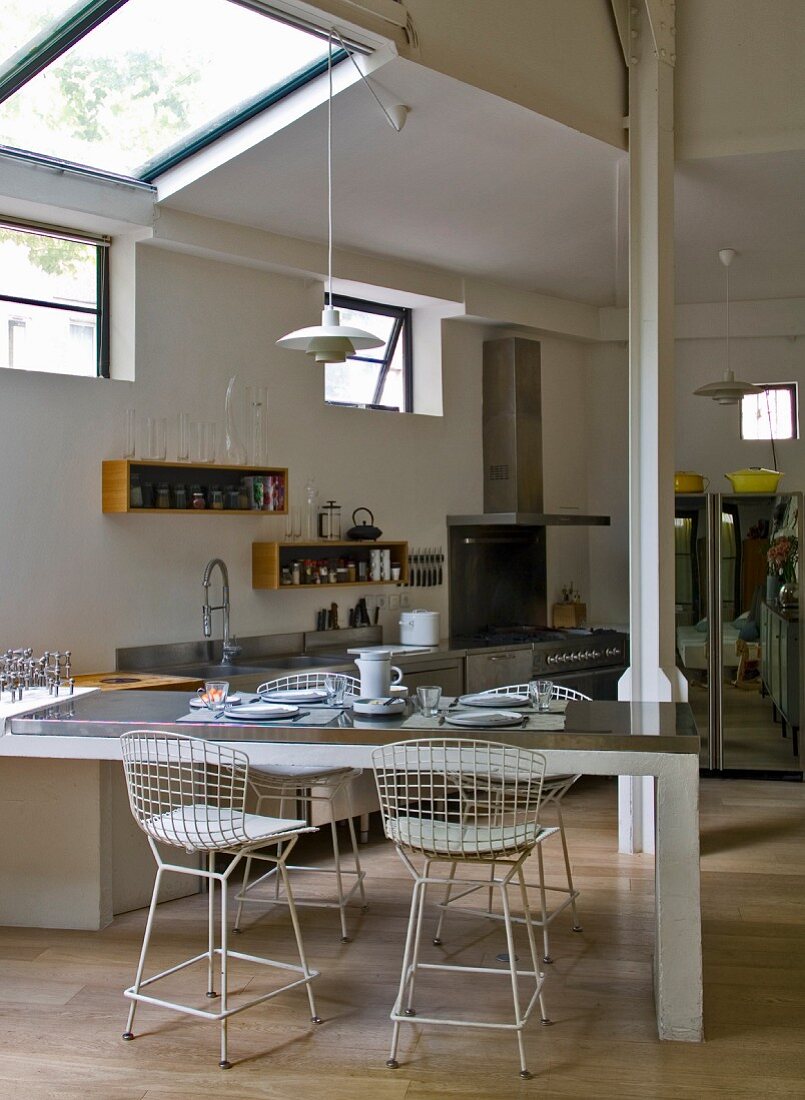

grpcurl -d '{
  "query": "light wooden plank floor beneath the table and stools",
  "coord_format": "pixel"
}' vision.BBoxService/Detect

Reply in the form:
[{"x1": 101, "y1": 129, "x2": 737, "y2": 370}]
[{"x1": 0, "y1": 779, "x2": 805, "y2": 1100}]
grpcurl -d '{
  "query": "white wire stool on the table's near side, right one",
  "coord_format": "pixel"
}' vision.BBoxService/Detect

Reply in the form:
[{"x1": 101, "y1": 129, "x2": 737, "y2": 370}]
[{"x1": 372, "y1": 739, "x2": 549, "y2": 1078}]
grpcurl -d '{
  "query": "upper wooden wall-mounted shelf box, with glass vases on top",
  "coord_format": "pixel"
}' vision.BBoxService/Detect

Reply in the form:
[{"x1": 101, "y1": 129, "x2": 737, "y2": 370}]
[{"x1": 101, "y1": 459, "x2": 288, "y2": 516}]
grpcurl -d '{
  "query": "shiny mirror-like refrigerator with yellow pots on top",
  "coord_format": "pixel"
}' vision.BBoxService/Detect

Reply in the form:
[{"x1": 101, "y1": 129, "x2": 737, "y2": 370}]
[{"x1": 674, "y1": 493, "x2": 805, "y2": 779}]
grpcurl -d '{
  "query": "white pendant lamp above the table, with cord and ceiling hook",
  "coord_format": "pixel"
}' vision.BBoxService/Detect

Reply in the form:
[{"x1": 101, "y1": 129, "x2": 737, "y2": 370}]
[{"x1": 277, "y1": 29, "x2": 408, "y2": 363}]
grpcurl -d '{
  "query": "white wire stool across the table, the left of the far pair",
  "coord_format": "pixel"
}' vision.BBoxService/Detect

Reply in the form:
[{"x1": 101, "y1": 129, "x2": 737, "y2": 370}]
[{"x1": 234, "y1": 672, "x2": 367, "y2": 944}]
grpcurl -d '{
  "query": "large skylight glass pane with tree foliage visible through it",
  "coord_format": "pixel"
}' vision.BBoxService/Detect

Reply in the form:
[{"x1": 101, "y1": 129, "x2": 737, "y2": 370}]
[{"x1": 0, "y1": 0, "x2": 327, "y2": 176}]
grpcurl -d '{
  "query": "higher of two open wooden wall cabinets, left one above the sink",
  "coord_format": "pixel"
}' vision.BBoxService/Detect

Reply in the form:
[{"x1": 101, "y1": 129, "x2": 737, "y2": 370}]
[{"x1": 101, "y1": 459, "x2": 288, "y2": 516}]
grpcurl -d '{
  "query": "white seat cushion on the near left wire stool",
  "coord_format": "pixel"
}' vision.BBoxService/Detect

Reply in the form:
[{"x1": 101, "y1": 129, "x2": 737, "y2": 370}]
[{"x1": 145, "y1": 803, "x2": 309, "y2": 851}]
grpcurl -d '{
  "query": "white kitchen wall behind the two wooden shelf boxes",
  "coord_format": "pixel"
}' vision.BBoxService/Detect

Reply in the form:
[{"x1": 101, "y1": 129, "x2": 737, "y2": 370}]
[{"x1": 0, "y1": 245, "x2": 481, "y2": 672}]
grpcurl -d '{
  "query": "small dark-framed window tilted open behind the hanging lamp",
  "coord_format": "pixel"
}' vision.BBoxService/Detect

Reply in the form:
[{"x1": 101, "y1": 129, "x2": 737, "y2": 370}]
[{"x1": 324, "y1": 294, "x2": 413, "y2": 413}]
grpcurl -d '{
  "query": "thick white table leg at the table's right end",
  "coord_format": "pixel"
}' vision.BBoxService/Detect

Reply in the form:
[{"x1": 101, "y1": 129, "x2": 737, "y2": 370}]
[{"x1": 654, "y1": 755, "x2": 704, "y2": 1043}]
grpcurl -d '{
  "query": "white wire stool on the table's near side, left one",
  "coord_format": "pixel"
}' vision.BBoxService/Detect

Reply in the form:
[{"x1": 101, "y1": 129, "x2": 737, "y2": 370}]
[{"x1": 120, "y1": 729, "x2": 321, "y2": 1069}]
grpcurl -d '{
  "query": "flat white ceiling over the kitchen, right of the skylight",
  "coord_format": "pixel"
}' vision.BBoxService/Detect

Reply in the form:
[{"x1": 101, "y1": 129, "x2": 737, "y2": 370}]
[{"x1": 160, "y1": 58, "x2": 805, "y2": 306}]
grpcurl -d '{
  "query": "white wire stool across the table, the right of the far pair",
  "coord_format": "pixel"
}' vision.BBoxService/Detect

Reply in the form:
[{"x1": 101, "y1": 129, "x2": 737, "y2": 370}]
[{"x1": 433, "y1": 683, "x2": 591, "y2": 964}]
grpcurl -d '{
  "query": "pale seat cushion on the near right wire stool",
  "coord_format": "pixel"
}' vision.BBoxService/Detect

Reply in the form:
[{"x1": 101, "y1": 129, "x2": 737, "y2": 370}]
[{"x1": 387, "y1": 816, "x2": 559, "y2": 857}]
